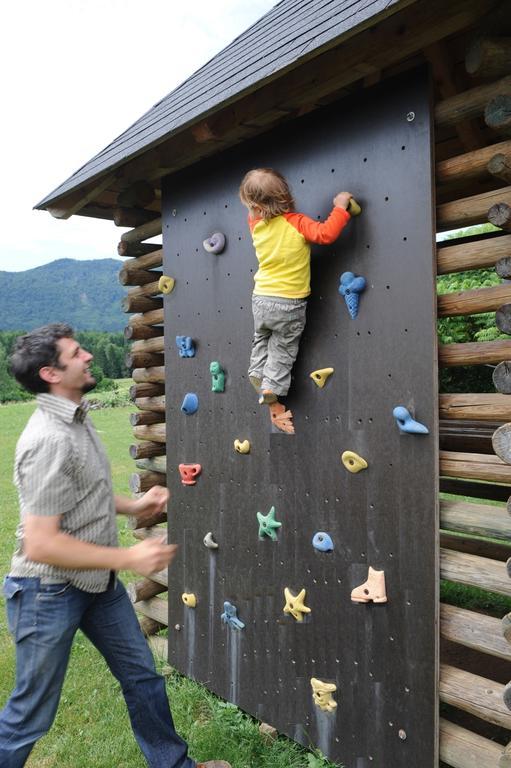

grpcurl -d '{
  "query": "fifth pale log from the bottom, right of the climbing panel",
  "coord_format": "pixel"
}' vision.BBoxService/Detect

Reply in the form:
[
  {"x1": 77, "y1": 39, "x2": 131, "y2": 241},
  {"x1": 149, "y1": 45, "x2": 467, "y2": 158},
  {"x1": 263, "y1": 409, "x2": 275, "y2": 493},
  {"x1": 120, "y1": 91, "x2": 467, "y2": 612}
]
[{"x1": 440, "y1": 498, "x2": 511, "y2": 541}]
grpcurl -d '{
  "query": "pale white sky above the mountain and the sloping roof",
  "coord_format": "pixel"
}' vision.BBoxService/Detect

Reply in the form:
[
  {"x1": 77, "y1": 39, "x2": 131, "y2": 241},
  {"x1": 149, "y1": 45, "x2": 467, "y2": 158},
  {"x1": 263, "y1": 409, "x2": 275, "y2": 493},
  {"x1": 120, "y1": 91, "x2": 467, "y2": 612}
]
[{"x1": 0, "y1": 0, "x2": 277, "y2": 272}]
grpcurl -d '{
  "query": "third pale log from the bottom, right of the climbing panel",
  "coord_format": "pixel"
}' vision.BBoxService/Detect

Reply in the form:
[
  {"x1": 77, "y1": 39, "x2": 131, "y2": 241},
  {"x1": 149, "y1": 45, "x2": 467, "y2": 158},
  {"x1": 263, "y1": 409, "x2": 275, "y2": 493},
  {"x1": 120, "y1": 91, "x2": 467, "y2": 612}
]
[{"x1": 440, "y1": 603, "x2": 511, "y2": 661}]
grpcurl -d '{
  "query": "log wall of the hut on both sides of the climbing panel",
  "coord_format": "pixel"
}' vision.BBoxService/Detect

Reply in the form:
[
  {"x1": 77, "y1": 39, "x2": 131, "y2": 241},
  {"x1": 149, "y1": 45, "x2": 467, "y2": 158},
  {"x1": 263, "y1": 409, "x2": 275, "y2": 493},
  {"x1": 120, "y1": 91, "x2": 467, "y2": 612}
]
[{"x1": 111, "y1": 6, "x2": 511, "y2": 768}]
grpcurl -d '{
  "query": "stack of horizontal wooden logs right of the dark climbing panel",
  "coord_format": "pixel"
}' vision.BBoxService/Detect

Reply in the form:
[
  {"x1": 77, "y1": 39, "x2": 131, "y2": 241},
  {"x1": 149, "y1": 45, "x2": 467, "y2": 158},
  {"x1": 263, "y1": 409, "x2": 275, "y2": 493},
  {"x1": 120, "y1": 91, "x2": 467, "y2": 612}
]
[{"x1": 435, "y1": 30, "x2": 511, "y2": 768}]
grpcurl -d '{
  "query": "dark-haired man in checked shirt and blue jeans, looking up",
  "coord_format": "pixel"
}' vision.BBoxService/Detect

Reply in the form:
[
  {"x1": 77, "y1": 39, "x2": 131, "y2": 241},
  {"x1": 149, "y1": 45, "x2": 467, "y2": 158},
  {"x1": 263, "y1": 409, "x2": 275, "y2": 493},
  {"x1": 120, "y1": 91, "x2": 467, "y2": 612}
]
[{"x1": 0, "y1": 323, "x2": 230, "y2": 768}]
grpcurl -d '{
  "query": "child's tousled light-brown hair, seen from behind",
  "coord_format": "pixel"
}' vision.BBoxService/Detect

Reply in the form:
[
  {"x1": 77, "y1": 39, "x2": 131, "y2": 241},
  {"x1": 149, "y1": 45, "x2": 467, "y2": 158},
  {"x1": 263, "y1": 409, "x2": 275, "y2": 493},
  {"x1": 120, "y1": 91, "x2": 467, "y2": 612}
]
[{"x1": 240, "y1": 168, "x2": 295, "y2": 221}]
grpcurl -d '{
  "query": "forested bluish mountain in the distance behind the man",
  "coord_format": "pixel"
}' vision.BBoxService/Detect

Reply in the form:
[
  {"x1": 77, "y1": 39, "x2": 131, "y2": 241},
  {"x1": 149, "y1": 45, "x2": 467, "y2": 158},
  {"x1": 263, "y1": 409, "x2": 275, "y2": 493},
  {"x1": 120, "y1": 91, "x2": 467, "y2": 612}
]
[{"x1": 0, "y1": 259, "x2": 126, "y2": 331}]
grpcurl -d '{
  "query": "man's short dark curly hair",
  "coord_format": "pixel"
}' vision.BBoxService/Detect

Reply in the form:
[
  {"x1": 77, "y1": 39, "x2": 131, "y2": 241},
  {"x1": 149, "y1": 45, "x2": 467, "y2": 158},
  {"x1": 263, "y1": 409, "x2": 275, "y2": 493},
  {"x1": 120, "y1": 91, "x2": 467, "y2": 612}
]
[{"x1": 9, "y1": 323, "x2": 74, "y2": 394}]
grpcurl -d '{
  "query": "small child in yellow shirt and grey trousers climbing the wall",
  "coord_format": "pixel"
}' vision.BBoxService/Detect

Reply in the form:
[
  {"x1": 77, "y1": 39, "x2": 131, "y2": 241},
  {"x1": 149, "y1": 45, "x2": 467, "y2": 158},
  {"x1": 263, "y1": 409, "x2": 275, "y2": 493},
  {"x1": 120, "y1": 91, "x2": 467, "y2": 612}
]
[{"x1": 240, "y1": 168, "x2": 352, "y2": 435}]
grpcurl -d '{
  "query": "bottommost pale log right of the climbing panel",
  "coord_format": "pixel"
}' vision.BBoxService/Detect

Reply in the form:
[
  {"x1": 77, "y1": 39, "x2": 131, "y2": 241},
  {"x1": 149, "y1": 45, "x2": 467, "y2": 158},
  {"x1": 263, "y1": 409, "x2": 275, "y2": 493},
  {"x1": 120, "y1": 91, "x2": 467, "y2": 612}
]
[{"x1": 440, "y1": 712, "x2": 503, "y2": 768}]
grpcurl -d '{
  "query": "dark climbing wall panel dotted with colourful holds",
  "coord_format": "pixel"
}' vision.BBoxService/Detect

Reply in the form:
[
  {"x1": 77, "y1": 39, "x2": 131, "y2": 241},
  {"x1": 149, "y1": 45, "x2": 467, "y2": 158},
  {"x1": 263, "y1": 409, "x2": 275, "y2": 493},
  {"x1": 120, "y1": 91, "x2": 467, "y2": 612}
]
[{"x1": 163, "y1": 71, "x2": 438, "y2": 768}]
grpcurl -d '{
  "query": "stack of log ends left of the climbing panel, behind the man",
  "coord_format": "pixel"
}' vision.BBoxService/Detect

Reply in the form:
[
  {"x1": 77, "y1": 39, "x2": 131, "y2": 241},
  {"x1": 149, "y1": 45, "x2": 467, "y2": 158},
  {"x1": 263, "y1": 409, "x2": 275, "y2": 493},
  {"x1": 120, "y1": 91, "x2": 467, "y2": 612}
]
[{"x1": 116, "y1": 212, "x2": 168, "y2": 657}]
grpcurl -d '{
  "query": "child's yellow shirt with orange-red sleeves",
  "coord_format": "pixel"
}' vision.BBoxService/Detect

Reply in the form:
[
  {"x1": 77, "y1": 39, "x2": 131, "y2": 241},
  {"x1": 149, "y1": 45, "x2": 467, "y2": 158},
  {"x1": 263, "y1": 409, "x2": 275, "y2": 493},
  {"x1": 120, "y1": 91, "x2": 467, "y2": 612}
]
[{"x1": 248, "y1": 208, "x2": 351, "y2": 299}]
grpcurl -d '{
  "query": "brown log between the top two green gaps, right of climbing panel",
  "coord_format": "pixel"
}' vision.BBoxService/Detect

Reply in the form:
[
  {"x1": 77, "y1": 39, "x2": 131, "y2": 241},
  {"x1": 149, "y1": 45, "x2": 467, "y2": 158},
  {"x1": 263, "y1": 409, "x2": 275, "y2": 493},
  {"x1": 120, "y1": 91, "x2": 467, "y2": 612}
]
[{"x1": 437, "y1": 235, "x2": 511, "y2": 275}]
